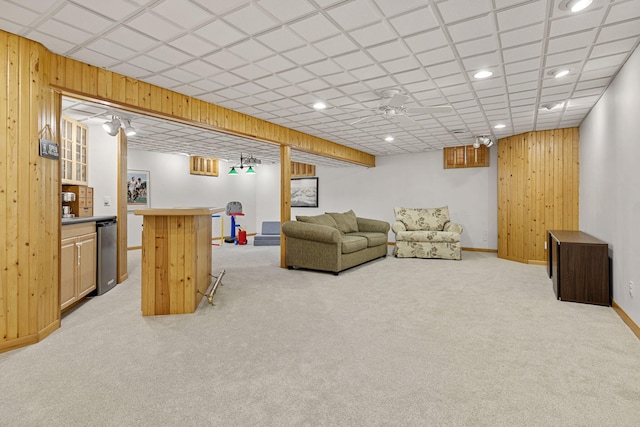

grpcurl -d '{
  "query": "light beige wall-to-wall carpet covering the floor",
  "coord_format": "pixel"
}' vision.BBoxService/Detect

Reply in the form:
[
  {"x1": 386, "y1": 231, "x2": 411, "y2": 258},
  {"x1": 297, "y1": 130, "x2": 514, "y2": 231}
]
[{"x1": 0, "y1": 245, "x2": 640, "y2": 426}]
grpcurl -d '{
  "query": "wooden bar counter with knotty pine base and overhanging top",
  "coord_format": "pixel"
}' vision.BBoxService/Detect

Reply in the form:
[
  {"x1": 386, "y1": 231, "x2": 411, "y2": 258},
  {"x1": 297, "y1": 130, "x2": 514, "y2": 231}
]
[{"x1": 133, "y1": 208, "x2": 225, "y2": 316}]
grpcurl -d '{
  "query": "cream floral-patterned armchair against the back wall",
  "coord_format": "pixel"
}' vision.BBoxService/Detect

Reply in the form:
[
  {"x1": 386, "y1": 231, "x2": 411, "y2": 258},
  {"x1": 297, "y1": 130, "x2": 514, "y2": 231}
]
[{"x1": 391, "y1": 206, "x2": 463, "y2": 260}]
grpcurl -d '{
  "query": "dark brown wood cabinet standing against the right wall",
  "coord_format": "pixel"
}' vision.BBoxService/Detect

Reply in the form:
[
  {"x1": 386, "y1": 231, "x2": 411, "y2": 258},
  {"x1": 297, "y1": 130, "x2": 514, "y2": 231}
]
[{"x1": 547, "y1": 230, "x2": 611, "y2": 305}]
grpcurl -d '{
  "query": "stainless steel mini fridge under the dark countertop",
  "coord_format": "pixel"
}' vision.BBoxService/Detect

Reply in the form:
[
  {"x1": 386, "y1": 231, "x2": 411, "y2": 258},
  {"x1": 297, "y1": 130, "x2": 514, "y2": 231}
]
[{"x1": 96, "y1": 218, "x2": 118, "y2": 295}]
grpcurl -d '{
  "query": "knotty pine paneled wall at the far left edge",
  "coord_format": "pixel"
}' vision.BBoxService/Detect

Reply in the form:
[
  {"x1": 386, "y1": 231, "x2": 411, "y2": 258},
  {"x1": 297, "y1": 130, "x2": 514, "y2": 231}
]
[{"x1": 0, "y1": 31, "x2": 61, "y2": 352}]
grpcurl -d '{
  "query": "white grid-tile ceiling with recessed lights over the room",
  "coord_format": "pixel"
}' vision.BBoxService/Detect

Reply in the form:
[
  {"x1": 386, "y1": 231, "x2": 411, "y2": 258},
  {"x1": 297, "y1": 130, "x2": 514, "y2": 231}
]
[{"x1": 0, "y1": 0, "x2": 640, "y2": 165}]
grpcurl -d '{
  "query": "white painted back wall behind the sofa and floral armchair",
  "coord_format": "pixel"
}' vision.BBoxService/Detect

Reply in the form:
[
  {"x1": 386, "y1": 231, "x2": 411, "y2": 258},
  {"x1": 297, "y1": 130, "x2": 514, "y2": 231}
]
[{"x1": 252, "y1": 148, "x2": 498, "y2": 249}]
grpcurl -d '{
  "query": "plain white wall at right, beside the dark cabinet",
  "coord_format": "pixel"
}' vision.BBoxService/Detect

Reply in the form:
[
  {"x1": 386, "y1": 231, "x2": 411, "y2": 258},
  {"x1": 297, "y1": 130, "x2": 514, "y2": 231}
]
[{"x1": 580, "y1": 44, "x2": 640, "y2": 325}]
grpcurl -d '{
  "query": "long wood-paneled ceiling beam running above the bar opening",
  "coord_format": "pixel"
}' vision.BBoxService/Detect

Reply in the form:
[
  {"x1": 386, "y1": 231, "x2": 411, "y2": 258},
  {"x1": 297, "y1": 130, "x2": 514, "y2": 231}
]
[{"x1": 50, "y1": 53, "x2": 375, "y2": 167}]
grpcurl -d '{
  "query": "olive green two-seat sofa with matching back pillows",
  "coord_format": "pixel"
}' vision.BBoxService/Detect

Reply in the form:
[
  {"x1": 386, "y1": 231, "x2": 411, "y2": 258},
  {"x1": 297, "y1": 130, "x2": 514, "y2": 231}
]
[{"x1": 282, "y1": 211, "x2": 390, "y2": 275}]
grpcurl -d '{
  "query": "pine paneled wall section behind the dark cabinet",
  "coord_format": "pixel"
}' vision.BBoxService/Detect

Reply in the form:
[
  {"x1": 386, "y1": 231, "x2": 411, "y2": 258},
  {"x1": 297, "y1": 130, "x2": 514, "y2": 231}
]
[{"x1": 498, "y1": 128, "x2": 579, "y2": 264}]
